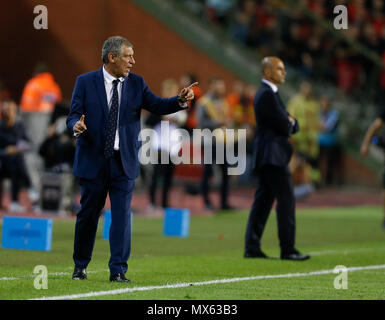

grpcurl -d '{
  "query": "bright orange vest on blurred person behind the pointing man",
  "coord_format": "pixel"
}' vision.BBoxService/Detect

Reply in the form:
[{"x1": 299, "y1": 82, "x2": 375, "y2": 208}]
[{"x1": 20, "y1": 72, "x2": 62, "y2": 112}]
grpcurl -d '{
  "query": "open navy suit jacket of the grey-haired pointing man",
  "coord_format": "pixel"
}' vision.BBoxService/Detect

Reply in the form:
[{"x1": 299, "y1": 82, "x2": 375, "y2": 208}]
[{"x1": 67, "y1": 67, "x2": 183, "y2": 179}]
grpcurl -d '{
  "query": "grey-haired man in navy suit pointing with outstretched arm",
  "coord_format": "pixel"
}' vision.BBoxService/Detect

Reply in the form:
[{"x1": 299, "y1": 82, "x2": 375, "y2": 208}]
[{"x1": 67, "y1": 36, "x2": 197, "y2": 282}]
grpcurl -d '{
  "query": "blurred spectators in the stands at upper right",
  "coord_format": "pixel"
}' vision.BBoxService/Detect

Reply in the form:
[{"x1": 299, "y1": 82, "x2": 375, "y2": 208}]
[{"x1": 184, "y1": 0, "x2": 385, "y2": 99}]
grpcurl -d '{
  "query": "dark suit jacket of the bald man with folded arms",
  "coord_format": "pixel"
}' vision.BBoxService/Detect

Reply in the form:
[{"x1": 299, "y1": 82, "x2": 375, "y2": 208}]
[{"x1": 253, "y1": 82, "x2": 299, "y2": 171}]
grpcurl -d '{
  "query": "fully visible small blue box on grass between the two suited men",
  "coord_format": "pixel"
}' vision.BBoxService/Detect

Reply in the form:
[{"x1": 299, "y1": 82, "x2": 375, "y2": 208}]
[{"x1": 163, "y1": 208, "x2": 190, "y2": 238}]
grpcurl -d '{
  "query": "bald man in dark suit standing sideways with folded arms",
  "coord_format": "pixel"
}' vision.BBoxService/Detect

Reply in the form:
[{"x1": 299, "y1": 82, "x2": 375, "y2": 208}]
[{"x1": 244, "y1": 57, "x2": 310, "y2": 260}]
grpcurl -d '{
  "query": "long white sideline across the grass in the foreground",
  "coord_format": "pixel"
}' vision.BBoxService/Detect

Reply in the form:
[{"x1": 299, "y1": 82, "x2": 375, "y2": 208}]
[{"x1": 28, "y1": 264, "x2": 385, "y2": 300}]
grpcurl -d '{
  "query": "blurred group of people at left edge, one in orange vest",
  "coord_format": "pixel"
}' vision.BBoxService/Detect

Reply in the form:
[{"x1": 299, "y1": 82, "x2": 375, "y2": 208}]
[{"x1": 0, "y1": 62, "x2": 77, "y2": 212}]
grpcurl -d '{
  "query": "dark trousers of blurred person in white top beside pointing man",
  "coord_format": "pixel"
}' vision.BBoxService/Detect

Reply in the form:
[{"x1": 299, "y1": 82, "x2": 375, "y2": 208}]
[{"x1": 149, "y1": 153, "x2": 175, "y2": 208}]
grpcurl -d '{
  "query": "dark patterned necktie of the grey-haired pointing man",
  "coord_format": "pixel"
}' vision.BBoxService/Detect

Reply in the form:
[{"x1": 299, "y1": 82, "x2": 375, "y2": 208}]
[{"x1": 104, "y1": 80, "x2": 119, "y2": 159}]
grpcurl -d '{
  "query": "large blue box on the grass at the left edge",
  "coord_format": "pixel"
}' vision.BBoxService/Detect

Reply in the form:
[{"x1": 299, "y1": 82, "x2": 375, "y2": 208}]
[{"x1": 1, "y1": 216, "x2": 52, "y2": 251}]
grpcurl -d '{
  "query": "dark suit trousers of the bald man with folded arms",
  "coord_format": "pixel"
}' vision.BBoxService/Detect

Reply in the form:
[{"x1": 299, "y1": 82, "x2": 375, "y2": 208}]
[{"x1": 245, "y1": 165, "x2": 295, "y2": 253}]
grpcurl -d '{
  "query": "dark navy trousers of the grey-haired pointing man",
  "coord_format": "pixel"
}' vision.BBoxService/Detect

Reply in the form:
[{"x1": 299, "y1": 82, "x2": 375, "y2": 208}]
[{"x1": 73, "y1": 152, "x2": 135, "y2": 274}]
